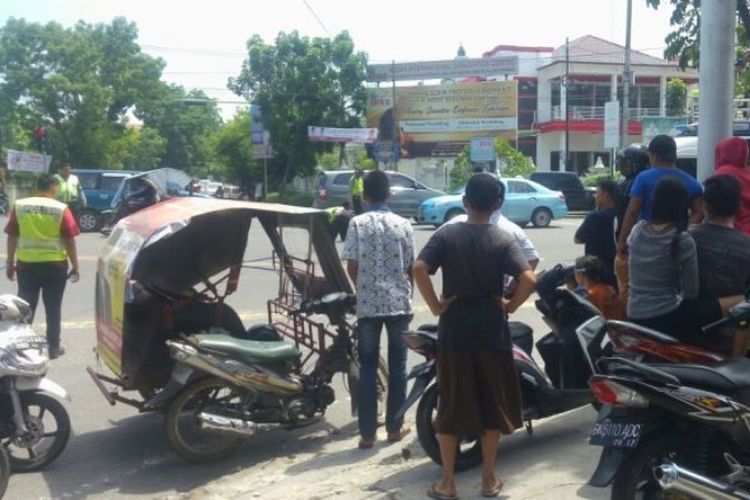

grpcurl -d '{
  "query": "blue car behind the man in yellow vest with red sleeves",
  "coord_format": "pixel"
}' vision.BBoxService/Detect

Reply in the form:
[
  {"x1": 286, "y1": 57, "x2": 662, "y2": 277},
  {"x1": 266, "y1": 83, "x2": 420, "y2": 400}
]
[{"x1": 73, "y1": 169, "x2": 138, "y2": 232}]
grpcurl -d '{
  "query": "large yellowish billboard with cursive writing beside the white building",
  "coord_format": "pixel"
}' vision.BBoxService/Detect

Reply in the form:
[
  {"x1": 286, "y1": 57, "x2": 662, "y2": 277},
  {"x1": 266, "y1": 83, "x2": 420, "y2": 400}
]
[{"x1": 367, "y1": 81, "x2": 518, "y2": 158}]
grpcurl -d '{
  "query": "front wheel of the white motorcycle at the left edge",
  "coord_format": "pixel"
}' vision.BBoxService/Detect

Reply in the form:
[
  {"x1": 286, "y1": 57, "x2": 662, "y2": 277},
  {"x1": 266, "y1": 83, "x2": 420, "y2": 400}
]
[{"x1": 3, "y1": 392, "x2": 70, "y2": 472}]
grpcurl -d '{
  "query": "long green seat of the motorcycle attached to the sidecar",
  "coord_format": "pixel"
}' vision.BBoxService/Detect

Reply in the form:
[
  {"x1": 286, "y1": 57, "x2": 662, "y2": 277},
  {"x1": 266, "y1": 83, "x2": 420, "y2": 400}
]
[{"x1": 195, "y1": 334, "x2": 301, "y2": 363}]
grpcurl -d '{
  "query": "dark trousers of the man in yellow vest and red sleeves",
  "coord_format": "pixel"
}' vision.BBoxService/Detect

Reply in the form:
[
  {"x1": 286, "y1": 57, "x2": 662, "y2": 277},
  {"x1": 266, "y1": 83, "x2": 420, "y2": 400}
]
[{"x1": 18, "y1": 262, "x2": 68, "y2": 350}]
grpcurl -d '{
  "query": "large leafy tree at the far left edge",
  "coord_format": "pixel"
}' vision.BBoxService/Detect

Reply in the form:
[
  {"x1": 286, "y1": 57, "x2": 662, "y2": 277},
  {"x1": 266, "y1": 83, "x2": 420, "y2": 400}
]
[{"x1": 0, "y1": 18, "x2": 164, "y2": 166}]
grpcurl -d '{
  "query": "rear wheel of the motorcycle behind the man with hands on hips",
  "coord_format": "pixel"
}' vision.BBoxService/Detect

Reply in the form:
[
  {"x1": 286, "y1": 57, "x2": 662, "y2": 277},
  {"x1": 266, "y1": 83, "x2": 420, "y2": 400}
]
[{"x1": 417, "y1": 384, "x2": 482, "y2": 471}]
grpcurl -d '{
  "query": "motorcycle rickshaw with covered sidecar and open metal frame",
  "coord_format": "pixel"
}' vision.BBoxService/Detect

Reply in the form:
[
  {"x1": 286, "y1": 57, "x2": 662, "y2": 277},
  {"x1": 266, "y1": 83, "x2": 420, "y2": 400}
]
[{"x1": 88, "y1": 197, "x2": 388, "y2": 462}]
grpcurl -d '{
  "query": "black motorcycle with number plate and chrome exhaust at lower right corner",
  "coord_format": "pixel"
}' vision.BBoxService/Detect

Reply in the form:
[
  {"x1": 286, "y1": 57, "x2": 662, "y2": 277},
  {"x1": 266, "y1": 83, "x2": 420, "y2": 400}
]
[{"x1": 589, "y1": 303, "x2": 750, "y2": 500}]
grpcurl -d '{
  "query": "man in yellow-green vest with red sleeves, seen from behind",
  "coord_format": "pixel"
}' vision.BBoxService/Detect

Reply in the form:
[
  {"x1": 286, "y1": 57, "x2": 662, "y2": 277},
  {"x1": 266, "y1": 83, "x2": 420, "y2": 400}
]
[{"x1": 5, "y1": 174, "x2": 80, "y2": 359}]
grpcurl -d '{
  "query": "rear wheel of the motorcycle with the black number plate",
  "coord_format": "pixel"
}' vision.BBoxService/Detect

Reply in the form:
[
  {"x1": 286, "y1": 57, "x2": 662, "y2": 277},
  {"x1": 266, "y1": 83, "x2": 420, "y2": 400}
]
[{"x1": 611, "y1": 432, "x2": 694, "y2": 500}]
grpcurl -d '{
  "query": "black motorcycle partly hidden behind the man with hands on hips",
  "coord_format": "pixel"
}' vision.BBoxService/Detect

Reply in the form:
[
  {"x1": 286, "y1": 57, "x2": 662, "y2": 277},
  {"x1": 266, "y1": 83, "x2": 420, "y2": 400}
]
[{"x1": 398, "y1": 266, "x2": 607, "y2": 470}]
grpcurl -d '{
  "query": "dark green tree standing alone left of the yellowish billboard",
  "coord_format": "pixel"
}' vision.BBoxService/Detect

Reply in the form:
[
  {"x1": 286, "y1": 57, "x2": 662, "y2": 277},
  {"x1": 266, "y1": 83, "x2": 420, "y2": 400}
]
[{"x1": 229, "y1": 31, "x2": 367, "y2": 192}]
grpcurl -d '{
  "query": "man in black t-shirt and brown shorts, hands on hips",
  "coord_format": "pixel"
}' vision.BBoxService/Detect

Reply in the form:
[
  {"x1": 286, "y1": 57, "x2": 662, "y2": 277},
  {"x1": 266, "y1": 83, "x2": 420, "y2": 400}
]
[{"x1": 414, "y1": 173, "x2": 536, "y2": 499}]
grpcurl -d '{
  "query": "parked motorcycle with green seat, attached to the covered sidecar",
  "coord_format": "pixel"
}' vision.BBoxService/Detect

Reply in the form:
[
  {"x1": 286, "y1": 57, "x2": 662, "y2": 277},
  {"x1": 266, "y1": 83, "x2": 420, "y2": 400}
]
[{"x1": 165, "y1": 293, "x2": 356, "y2": 461}]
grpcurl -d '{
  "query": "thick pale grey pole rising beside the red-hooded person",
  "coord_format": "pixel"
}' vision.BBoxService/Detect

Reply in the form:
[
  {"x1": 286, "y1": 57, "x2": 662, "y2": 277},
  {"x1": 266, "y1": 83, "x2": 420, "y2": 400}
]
[{"x1": 697, "y1": 0, "x2": 737, "y2": 181}]
